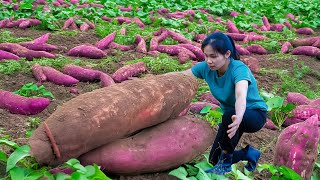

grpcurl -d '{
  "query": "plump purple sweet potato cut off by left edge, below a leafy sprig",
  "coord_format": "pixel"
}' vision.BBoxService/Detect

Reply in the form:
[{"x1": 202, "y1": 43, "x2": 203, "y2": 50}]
[{"x1": 0, "y1": 90, "x2": 50, "y2": 115}]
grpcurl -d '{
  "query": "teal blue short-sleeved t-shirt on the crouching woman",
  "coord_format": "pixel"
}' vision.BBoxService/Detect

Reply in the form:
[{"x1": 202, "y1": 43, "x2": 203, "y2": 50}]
[{"x1": 191, "y1": 58, "x2": 268, "y2": 112}]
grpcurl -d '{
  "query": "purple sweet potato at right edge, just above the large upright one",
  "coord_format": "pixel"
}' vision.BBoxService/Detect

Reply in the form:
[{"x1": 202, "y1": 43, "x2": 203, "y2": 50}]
[{"x1": 291, "y1": 105, "x2": 320, "y2": 120}]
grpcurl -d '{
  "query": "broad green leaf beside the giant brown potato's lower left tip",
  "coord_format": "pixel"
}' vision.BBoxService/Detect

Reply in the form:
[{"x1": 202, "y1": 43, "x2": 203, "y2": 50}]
[{"x1": 6, "y1": 145, "x2": 30, "y2": 172}]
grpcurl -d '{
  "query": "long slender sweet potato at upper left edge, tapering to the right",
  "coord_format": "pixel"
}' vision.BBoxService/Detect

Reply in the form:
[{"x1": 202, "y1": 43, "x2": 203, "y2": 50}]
[{"x1": 0, "y1": 43, "x2": 55, "y2": 60}]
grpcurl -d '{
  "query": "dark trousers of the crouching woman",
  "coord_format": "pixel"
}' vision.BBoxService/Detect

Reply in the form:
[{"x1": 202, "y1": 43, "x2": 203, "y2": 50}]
[{"x1": 209, "y1": 109, "x2": 267, "y2": 165}]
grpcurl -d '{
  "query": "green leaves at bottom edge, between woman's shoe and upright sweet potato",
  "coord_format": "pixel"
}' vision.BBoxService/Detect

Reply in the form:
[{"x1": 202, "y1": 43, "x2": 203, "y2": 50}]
[{"x1": 257, "y1": 164, "x2": 302, "y2": 180}]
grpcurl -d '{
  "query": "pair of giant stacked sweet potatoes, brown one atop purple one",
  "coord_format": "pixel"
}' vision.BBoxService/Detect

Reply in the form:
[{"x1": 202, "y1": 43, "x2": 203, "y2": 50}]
[{"x1": 29, "y1": 73, "x2": 213, "y2": 174}]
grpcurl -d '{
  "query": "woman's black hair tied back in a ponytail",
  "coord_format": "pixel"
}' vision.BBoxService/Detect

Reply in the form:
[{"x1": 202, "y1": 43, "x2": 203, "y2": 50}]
[{"x1": 201, "y1": 32, "x2": 240, "y2": 60}]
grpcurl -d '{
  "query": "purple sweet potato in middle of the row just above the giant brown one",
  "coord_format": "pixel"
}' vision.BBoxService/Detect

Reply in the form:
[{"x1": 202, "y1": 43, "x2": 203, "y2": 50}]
[{"x1": 63, "y1": 64, "x2": 100, "y2": 81}]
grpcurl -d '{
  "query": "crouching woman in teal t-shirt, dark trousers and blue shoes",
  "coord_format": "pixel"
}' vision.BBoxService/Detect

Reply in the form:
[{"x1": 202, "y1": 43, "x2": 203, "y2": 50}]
[{"x1": 179, "y1": 32, "x2": 267, "y2": 174}]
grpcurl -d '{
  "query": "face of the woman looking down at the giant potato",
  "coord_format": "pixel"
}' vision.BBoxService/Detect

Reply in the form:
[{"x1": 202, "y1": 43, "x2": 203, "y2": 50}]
[{"x1": 203, "y1": 45, "x2": 230, "y2": 70}]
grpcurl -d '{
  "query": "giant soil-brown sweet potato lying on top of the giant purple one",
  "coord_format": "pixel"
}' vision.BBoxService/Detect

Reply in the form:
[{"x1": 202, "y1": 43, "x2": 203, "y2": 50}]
[{"x1": 29, "y1": 73, "x2": 198, "y2": 165}]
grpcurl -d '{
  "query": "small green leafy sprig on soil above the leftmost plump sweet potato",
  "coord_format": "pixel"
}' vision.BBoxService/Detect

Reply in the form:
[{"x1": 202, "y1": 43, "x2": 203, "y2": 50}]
[{"x1": 13, "y1": 82, "x2": 54, "y2": 99}]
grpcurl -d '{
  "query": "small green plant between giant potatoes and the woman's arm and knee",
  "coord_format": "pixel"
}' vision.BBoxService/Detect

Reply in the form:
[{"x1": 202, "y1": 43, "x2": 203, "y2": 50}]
[{"x1": 200, "y1": 106, "x2": 223, "y2": 126}]
